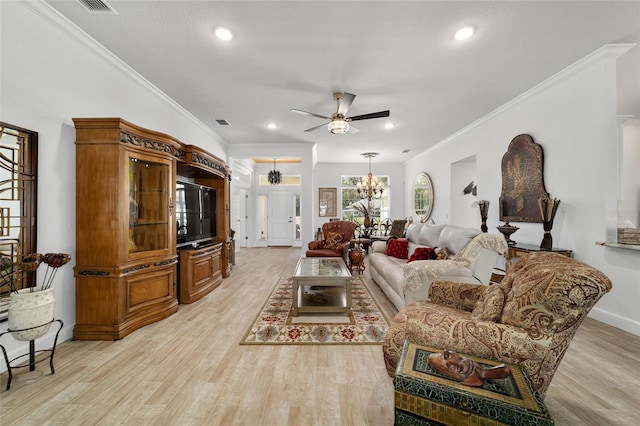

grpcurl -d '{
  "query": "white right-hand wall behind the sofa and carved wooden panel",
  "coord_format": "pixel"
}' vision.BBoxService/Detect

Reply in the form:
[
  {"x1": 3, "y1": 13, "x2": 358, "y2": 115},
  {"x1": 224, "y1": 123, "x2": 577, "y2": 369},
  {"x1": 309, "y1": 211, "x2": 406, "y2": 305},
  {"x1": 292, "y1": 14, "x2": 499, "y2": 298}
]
[{"x1": 405, "y1": 45, "x2": 640, "y2": 335}]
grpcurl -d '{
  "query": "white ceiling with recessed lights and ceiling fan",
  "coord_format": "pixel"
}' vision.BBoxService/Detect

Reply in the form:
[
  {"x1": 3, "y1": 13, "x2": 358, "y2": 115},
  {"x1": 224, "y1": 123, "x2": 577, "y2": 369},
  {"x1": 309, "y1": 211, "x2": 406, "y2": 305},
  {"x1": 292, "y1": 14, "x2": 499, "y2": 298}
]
[{"x1": 48, "y1": 0, "x2": 640, "y2": 163}]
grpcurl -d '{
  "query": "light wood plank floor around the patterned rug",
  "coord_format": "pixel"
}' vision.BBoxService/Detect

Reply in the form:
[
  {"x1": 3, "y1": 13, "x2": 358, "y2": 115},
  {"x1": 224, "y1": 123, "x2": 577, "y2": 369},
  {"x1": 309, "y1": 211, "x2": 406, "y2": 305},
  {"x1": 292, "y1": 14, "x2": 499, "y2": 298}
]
[{"x1": 0, "y1": 248, "x2": 640, "y2": 426}]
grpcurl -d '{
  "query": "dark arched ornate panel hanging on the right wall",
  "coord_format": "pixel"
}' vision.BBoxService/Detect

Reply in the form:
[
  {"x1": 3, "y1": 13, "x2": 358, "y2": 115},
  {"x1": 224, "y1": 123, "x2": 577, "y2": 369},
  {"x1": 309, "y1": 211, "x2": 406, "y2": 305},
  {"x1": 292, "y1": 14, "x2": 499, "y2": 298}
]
[{"x1": 500, "y1": 134, "x2": 549, "y2": 222}]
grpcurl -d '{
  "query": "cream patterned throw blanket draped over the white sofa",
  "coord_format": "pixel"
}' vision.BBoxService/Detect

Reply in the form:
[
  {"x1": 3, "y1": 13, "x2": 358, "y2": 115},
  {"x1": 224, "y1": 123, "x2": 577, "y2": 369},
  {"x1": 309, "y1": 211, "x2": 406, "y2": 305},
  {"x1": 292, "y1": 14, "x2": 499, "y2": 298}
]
[{"x1": 402, "y1": 233, "x2": 508, "y2": 294}]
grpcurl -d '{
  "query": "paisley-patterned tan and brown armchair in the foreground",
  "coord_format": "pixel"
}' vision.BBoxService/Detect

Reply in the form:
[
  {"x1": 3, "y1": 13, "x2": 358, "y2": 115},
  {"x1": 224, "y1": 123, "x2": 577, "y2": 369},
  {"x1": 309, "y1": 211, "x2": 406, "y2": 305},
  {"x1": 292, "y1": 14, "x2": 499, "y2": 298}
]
[{"x1": 383, "y1": 252, "x2": 611, "y2": 398}]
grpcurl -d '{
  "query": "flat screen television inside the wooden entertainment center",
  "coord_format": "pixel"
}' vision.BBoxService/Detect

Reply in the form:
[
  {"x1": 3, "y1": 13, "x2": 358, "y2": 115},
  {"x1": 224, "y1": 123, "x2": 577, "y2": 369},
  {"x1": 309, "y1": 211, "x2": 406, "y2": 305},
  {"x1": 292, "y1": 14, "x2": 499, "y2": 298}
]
[{"x1": 176, "y1": 181, "x2": 216, "y2": 247}]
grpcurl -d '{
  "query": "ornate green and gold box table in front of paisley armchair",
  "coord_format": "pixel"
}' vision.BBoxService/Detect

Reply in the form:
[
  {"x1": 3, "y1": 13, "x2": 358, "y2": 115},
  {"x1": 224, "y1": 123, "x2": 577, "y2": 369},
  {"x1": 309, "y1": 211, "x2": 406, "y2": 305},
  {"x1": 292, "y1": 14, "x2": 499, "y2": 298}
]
[{"x1": 394, "y1": 341, "x2": 554, "y2": 426}]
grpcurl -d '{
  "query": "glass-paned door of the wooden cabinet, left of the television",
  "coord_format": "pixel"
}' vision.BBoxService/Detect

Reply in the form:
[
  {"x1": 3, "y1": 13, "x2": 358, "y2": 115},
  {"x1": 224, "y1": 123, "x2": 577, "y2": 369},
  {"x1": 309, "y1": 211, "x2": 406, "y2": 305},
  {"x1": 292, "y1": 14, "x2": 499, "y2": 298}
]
[{"x1": 129, "y1": 156, "x2": 173, "y2": 254}]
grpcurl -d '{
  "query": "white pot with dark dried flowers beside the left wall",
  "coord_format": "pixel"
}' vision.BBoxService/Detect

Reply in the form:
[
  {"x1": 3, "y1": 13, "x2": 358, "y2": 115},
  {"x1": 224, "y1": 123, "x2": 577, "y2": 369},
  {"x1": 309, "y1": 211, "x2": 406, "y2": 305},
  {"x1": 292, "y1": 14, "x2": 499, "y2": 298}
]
[{"x1": 0, "y1": 253, "x2": 71, "y2": 341}]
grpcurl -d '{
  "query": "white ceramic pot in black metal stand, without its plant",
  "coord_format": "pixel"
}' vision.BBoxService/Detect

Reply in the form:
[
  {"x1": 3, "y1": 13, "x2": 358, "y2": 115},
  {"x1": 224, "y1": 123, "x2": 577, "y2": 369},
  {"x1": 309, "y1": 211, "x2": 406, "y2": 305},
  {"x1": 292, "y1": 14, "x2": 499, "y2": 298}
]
[{"x1": 9, "y1": 288, "x2": 56, "y2": 341}]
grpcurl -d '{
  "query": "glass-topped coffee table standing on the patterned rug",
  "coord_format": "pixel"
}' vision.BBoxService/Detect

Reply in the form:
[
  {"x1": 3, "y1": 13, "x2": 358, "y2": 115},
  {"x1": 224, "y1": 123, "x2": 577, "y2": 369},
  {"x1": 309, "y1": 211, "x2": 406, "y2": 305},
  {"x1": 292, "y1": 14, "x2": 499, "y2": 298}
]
[{"x1": 291, "y1": 257, "x2": 352, "y2": 316}]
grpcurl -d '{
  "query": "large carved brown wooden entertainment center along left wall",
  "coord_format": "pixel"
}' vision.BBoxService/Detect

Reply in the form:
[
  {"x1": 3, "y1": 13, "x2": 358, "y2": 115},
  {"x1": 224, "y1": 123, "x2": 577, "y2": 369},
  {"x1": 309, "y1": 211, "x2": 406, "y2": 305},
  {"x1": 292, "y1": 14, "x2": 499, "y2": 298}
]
[{"x1": 73, "y1": 118, "x2": 231, "y2": 340}]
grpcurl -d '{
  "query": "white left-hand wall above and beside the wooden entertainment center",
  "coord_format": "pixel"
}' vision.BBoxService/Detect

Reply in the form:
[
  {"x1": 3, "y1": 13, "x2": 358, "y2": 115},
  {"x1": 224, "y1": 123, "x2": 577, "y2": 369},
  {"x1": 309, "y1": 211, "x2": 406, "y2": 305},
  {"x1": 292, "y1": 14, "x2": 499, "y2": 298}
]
[{"x1": 0, "y1": 1, "x2": 226, "y2": 358}]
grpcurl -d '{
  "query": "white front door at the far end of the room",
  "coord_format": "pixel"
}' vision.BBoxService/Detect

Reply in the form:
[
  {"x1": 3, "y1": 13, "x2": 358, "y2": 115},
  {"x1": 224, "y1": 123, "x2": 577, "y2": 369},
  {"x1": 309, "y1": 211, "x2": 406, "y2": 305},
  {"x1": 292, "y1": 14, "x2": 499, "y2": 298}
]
[{"x1": 267, "y1": 191, "x2": 293, "y2": 247}]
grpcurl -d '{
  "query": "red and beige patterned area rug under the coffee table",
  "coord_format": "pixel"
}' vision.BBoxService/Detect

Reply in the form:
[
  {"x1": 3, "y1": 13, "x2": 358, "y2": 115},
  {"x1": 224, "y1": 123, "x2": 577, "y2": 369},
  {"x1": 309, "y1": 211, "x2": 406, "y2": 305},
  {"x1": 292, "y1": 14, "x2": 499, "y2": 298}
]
[{"x1": 240, "y1": 277, "x2": 389, "y2": 345}]
